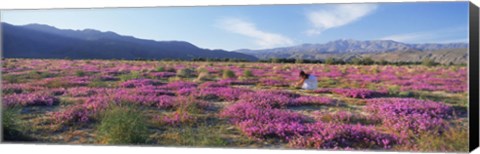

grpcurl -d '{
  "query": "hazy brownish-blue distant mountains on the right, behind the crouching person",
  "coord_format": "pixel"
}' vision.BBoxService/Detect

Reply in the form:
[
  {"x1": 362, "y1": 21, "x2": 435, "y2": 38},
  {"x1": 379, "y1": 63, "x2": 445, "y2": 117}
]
[{"x1": 236, "y1": 39, "x2": 468, "y2": 64}]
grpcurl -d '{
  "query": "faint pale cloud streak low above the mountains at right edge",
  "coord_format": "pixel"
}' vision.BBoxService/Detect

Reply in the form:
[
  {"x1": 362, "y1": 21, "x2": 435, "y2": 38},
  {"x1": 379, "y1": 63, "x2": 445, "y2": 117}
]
[{"x1": 380, "y1": 27, "x2": 468, "y2": 43}]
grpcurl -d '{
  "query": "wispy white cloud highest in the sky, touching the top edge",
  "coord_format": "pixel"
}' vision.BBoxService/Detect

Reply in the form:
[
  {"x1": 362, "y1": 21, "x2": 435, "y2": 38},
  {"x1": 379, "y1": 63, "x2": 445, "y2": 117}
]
[{"x1": 306, "y1": 4, "x2": 377, "y2": 35}]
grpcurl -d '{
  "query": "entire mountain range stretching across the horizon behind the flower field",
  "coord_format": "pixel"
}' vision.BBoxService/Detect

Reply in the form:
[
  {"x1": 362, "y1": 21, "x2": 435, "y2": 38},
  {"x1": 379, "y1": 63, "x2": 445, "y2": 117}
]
[{"x1": 1, "y1": 23, "x2": 468, "y2": 64}]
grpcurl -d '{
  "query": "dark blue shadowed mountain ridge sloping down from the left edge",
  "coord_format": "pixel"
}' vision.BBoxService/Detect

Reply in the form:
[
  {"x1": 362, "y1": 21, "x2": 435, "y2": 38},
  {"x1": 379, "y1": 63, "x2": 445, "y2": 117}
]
[{"x1": 1, "y1": 23, "x2": 257, "y2": 61}]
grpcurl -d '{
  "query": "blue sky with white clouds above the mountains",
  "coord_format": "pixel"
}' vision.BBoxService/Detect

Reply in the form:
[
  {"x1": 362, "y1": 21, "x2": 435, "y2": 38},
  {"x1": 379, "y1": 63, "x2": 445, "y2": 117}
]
[{"x1": 0, "y1": 2, "x2": 468, "y2": 50}]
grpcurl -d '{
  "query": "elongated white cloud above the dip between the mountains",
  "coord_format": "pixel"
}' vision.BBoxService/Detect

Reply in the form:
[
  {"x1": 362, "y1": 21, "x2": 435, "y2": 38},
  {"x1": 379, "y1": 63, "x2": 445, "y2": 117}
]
[{"x1": 218, "y1": 18, "x2": 293, "y2": 48}]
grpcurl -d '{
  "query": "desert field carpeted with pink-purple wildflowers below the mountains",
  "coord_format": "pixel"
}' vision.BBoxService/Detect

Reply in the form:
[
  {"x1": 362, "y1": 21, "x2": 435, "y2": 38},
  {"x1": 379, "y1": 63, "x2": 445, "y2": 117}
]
[{"x1": 1, "y1": 59, "x2": 468, "y2": 151}]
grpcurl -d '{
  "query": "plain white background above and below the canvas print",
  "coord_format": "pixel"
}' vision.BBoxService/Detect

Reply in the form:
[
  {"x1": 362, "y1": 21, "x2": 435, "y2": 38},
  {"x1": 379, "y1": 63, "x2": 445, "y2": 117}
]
[{"x1": 0, "y1": 0, "x2": 480, "y2": 154}]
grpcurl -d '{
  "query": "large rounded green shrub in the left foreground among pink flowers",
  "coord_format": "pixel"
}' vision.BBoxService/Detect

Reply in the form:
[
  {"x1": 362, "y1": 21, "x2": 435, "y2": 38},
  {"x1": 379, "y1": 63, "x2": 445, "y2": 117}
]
[{"x1": 98, "y1": 106, "x2": 148, "y2": 144}]
